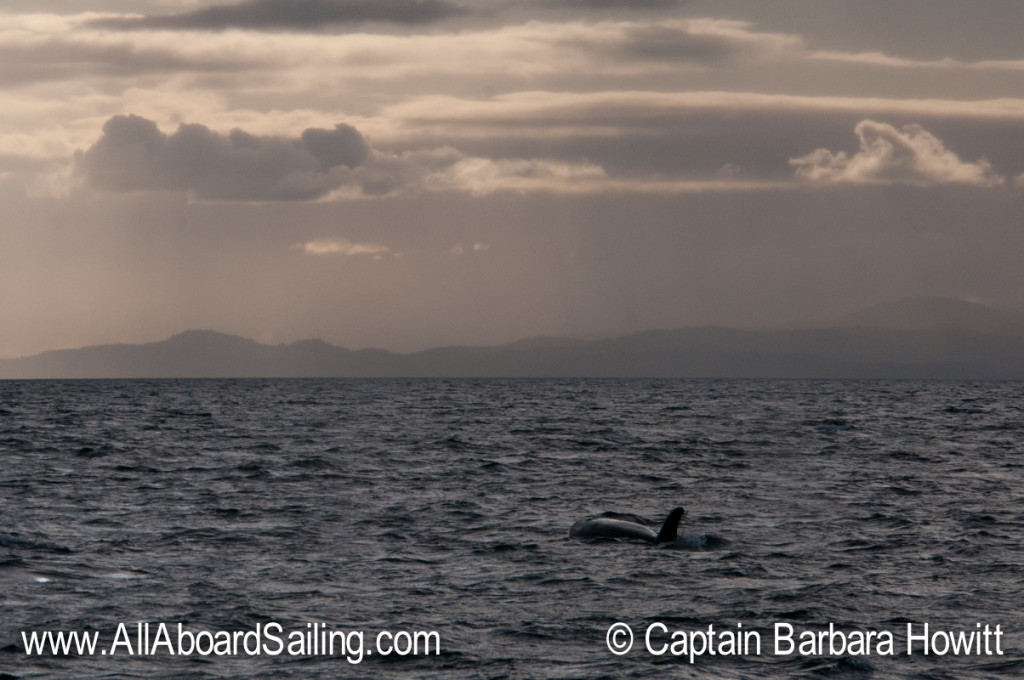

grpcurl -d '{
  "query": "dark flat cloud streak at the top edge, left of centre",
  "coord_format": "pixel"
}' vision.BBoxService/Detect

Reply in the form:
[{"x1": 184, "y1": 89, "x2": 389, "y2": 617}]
[{"x1": 95, "y1": 0, "x2": 466, "y2": 31}]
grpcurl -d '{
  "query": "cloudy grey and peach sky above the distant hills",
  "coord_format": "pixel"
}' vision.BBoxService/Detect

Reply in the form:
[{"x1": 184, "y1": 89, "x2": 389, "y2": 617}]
[{"x1": 0, "y1": 0, "x2": 1024, "y2": 357}]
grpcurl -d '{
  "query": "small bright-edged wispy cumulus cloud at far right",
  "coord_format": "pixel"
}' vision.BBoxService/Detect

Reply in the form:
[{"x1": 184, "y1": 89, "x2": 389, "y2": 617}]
[{"x1": 790, "y1": 120, "x2": 1005, "y2": 186}]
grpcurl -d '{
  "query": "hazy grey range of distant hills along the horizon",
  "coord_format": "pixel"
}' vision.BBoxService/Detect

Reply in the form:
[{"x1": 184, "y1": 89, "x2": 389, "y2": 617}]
[{"x1": 6, "y1": 298, "x2": 1024, "y2": 379}]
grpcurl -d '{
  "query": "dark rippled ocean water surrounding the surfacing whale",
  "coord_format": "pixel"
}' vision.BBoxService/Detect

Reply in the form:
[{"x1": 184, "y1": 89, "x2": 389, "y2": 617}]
[{"x1": 0, "y1": 380, "x2": 1024, "y2": 679}]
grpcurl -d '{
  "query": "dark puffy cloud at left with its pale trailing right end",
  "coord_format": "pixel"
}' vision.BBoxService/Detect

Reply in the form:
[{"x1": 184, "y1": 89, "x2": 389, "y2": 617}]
[{"x1": 76, "y1": 116, "x2": 622, "y2": 202}]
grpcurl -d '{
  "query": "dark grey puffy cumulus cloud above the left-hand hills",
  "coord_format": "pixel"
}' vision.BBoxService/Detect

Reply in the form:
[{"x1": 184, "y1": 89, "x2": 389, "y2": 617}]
[{"x1": 77, "y1": 116, "x2": 371, "y2": 201}]
